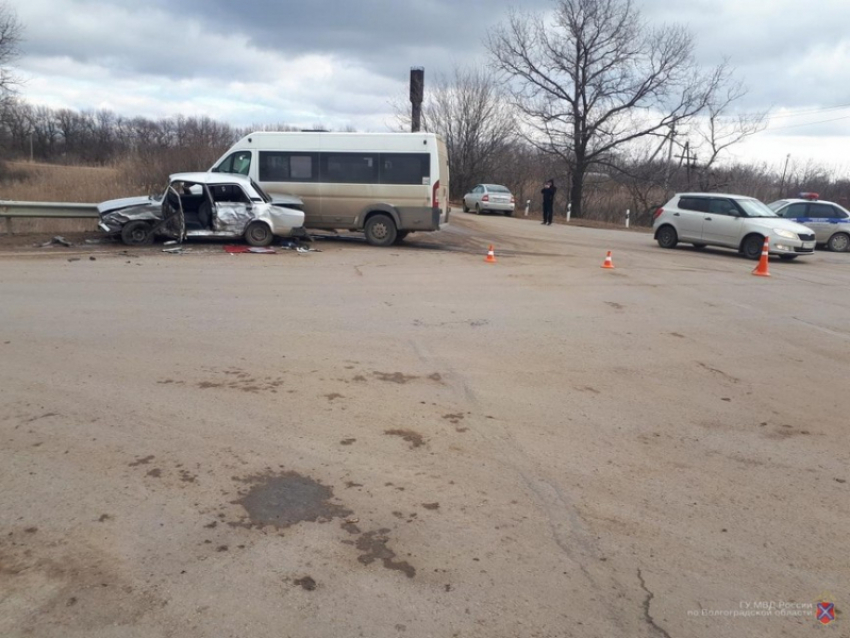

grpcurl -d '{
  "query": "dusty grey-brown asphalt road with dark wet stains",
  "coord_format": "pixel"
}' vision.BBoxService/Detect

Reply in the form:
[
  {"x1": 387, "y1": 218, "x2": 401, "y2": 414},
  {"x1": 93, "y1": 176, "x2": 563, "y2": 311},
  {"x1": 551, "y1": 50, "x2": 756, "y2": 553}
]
[{"x1": 0, "y1": 214, "x2": 850, "y2": 638}]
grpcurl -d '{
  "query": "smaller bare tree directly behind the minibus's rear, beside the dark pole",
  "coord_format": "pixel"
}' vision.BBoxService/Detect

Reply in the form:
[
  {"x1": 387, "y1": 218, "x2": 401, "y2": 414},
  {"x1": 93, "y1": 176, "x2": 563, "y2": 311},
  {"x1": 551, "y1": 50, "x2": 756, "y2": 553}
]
[{"x1": 396, "y1": 68, "x2": 516, "y2": 199}]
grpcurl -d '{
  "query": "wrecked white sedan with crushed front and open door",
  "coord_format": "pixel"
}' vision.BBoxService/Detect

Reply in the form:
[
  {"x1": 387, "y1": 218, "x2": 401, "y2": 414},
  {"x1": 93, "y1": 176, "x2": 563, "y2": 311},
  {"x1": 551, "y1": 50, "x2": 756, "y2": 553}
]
[{"x1": 97, "y1": 173, "x2": 304, "y2": 246}]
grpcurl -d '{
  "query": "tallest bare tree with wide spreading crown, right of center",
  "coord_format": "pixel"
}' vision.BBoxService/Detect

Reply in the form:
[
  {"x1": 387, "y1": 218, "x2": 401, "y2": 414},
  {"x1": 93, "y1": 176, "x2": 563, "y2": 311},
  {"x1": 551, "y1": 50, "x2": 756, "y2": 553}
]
[{"x1": 487, "y1": 0, "x2": 728, "y2": 216}]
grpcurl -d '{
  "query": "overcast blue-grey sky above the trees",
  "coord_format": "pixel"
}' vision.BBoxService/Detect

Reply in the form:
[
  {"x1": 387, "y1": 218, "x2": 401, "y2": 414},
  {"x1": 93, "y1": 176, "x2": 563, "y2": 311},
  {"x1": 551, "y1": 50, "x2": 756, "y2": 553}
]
[{"x1": 9, "y1": 0, "x2": 850, "y2": 170}]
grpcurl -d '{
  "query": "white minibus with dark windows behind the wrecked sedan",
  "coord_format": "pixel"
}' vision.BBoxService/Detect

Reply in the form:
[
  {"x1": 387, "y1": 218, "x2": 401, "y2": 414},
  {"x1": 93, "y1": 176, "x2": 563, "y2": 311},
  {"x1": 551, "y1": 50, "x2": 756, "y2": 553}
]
[{"x1": 210, "y1": 131, "x2": 450, "y2": 246}]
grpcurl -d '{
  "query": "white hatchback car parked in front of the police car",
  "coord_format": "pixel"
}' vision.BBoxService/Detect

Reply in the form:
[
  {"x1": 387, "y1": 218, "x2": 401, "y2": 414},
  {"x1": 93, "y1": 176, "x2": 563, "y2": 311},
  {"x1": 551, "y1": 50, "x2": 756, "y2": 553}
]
[{"x1": 652, "y1": 193, "x2": 815, "y2": 260}]
